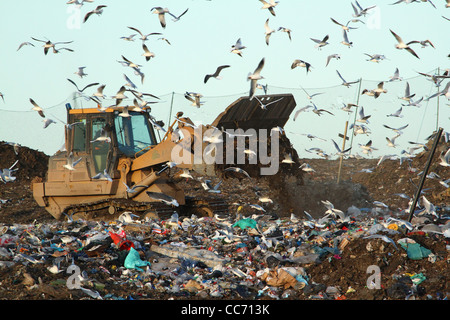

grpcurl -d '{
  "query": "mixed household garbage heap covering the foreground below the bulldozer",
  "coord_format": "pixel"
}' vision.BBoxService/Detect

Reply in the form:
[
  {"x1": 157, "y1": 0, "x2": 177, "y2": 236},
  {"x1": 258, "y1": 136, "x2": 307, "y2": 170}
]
[{"x1": 0, "y1": 201, "x2": 450, "y2": 300}]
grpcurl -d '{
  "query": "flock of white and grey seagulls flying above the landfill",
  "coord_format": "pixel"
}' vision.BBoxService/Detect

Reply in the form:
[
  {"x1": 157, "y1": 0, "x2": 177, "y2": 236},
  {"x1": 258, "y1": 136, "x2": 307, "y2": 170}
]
[{"x1": 0, "y1": 0, "x2": 450, "y2": 219}]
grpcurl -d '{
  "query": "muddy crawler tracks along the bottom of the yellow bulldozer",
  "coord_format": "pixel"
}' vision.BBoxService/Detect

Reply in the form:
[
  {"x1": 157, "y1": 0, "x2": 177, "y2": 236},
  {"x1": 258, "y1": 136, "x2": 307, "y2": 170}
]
[{"x1": 64, "y1": 197, "x2": 229, "y2": 219}]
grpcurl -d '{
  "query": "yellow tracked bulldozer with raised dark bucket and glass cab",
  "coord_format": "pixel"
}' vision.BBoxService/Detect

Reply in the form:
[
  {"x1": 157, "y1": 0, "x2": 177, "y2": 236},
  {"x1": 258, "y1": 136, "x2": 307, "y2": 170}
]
[{"x1": 33, "y1": 94, "x2": 295, "y2": 219}]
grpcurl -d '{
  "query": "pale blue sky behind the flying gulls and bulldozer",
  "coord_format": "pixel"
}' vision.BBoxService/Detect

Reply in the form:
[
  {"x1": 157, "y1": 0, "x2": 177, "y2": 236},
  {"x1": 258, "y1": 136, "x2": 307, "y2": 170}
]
[{"x1": 0, "y1": 0, "x2": 450, "y2": 157}]
